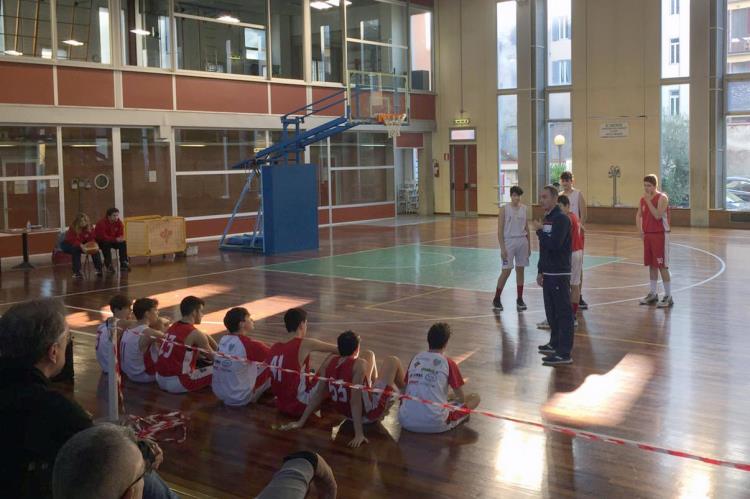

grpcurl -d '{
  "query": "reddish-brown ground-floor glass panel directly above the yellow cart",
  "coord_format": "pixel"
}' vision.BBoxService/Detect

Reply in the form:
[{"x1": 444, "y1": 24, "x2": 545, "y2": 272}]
[{"x1": 120, "y1": 128, "x2": 172, "y2": 217}]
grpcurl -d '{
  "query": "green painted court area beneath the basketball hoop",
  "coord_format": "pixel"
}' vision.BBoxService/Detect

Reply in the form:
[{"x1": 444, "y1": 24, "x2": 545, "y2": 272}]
[{"x1": 257, "y1": 244, "x2": 622, "y2": 291}]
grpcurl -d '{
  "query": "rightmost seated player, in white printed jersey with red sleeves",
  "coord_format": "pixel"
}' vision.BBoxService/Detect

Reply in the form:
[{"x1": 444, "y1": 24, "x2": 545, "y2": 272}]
[{"x1": 398, "y1": 322, "x2": 479, "y2": 433}]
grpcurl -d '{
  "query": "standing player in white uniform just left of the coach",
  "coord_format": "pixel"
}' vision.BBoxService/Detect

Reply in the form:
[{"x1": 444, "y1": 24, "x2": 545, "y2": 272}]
[{"x1": 492, "y1": 185, "x2": 531, "y2": 312}]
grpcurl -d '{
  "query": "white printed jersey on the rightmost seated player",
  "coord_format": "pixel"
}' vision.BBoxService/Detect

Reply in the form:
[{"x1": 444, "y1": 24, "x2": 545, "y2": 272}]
[{"x1": 398, "y1": 352, "x2": 464, "y2": 433}]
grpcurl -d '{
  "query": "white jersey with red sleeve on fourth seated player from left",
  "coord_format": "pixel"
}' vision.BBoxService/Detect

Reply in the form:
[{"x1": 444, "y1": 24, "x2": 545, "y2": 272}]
[{"x1": 211, "y1": 334, "x2": 271, "y2": 406}]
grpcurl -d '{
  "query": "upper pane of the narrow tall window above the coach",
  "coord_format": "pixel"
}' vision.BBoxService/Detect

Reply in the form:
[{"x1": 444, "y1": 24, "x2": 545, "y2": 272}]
[{"x1": 547, "y1": 0, "x2": 573, "y2": 86}]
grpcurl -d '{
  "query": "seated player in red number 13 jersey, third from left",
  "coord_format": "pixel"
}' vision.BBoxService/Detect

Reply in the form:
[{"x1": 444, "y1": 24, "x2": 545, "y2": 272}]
[{"x1": 156, "y1": 296, "x2": 216, "y2": 393}]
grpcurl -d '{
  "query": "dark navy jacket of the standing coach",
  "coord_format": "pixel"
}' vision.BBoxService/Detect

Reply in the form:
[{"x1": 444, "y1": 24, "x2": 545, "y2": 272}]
[{"x1": 536, "y1": 206, "x2": 572, "y2": 274}]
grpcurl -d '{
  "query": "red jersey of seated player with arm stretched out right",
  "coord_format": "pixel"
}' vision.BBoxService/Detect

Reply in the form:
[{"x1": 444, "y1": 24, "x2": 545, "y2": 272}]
[{"x1": 266, "y1": 338, "x2": 314, "y2": 416}]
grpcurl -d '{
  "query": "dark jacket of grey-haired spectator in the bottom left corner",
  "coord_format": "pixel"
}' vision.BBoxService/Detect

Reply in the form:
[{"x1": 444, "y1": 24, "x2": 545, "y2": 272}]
[{"x1": 0, "y1": 360, "x2": 93, "y2": 499}]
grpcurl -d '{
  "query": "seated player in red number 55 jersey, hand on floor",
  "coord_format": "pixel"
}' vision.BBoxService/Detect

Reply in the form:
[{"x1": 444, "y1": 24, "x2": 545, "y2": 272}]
[{"x1": 282, "y1": 331, "x2": 406, "y2": 447}]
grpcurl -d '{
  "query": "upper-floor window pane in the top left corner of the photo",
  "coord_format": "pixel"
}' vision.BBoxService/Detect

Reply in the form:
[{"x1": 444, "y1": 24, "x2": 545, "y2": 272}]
[{"x1": 0, "y1": 0, "x2": 52, "y2": 59}]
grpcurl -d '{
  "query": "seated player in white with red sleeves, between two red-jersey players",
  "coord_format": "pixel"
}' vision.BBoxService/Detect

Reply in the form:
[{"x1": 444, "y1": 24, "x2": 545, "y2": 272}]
[{"x1": 211, "y1": 307, "x2": 271, "y2": 406}]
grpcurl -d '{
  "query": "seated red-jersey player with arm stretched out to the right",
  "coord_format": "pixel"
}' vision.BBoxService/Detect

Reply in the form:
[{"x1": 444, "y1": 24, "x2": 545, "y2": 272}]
[{"x1": 266, "y1": 308, "x2": 337, "y2": 418}]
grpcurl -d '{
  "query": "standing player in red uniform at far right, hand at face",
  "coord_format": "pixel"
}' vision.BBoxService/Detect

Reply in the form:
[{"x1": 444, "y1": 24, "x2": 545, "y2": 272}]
[{"x1": 635, "y1": 174, "x2": 674, "y2": 308}]
